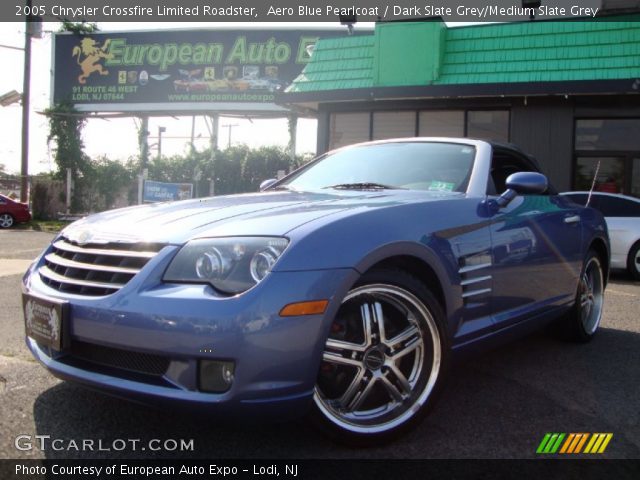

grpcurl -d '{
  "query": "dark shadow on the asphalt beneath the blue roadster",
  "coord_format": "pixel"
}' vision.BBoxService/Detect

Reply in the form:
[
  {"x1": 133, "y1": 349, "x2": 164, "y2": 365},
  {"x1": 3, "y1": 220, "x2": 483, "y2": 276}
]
[{"x1": 34, "y1": 328, "x2": 640, "y2": 459}]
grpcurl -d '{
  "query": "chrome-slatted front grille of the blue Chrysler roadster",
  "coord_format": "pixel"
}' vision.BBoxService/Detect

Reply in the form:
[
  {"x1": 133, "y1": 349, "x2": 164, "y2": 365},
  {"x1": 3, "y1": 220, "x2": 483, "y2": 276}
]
[{"x1": 39, "y1": 238, "x2": 163, "y2": 297}]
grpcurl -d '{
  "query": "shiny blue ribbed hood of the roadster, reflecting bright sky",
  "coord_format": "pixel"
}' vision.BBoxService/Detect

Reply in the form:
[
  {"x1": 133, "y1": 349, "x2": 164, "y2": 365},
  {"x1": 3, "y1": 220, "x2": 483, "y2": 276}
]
[{"x1": 63, "y1": 190, "x2": 462, "y2": 244}]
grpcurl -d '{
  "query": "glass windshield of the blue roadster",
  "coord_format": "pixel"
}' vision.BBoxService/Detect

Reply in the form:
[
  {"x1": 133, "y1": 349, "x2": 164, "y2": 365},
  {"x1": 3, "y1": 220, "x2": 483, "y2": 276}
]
[{"x1": 278, "y1": 142, "x2": 475, "y2": 192}]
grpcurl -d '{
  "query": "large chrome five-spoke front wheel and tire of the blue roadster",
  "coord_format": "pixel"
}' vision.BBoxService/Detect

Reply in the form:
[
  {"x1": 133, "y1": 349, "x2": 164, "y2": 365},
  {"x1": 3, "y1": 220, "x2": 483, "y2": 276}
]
[{"x1": 311, "y1": 270, "x2": 450, "y2": 446}]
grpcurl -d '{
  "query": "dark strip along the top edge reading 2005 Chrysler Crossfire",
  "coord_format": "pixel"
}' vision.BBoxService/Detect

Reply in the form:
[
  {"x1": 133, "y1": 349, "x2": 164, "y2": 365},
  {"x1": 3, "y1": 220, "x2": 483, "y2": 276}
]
[{"x1": 6, "y1": 0, "x2": 616, "y2": 22}]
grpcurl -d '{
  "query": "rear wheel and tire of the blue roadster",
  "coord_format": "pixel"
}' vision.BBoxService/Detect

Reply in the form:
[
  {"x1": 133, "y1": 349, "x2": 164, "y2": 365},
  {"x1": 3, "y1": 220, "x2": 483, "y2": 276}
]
[{"x1": 561, "y1": 250, "x2": 604, "y2": 343}]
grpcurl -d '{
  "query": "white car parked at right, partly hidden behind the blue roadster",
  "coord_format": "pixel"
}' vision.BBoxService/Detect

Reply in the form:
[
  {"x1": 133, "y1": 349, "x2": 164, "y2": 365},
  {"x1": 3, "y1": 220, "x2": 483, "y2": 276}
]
[{"x1": 562, "y1": 192, "x2": 640, "y2": 280}]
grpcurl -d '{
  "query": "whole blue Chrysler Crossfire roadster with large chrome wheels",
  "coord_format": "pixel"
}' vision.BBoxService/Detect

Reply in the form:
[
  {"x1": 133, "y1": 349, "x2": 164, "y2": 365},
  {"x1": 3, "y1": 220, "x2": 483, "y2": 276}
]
[{"x1": 23, "y1": 138, "x2": 609, "y2": 445}]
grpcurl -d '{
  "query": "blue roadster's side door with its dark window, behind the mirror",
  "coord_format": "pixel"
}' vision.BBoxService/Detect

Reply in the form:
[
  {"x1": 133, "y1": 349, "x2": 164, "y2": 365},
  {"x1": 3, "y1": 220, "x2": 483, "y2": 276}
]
[{"x1": 488, "y1": 148, "x2": 582, "y2": 328}]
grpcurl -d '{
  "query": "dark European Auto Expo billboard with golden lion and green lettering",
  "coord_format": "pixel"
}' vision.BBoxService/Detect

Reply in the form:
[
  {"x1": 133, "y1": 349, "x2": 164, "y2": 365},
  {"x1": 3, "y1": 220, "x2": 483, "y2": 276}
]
[{"x1": 53, "y1": 29, "x2": 346, "y2": 111}]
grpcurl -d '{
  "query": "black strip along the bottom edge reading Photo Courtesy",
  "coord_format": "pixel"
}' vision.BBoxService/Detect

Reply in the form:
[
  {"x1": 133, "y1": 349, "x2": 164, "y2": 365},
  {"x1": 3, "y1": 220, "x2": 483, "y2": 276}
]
[{"x1": 0, "y1": 458, "x2": 640, "y2": 480}]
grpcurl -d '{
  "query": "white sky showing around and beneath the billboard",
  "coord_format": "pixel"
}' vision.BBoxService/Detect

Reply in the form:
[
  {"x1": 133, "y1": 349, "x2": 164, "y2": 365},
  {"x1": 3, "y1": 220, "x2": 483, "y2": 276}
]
[{"x1": 0, "y1": 22, "x2": 366, "y2": 174}]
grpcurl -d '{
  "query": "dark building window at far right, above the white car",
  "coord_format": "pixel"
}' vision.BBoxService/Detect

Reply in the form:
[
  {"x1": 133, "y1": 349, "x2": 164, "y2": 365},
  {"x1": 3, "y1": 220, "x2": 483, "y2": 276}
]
[{"x1": 573, "y1": 118, "x2": 640, "y2": 197}]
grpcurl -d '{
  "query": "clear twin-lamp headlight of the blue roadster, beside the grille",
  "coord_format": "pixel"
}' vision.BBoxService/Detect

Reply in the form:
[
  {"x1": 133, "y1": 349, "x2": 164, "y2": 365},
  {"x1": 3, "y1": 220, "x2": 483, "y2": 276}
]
[{"x1": 163, "y1": 237, "x2": 289, "y2": 294}]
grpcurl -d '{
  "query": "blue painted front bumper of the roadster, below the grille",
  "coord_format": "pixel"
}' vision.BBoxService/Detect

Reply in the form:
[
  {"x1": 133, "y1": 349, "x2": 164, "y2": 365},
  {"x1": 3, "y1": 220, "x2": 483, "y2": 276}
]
[{"x1": 23, "y1": 247, "x2": 357, "y2": 419}]
